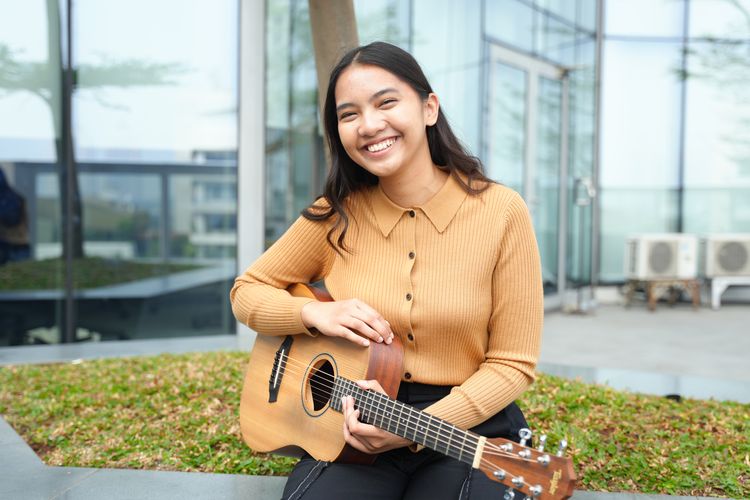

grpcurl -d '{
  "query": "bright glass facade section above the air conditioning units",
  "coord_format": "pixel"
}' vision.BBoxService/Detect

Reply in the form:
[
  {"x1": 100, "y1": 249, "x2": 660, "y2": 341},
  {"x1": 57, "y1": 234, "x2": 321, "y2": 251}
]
[{"x1": 598, "y1": 0, "x2": 750, "y2": 283}]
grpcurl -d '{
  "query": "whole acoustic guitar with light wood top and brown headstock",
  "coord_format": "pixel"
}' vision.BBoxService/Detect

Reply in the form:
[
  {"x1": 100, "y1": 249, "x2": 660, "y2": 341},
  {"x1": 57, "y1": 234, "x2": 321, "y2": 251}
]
[{"x1": 240, "y1": 285, "x2": 576, "y2": 500}]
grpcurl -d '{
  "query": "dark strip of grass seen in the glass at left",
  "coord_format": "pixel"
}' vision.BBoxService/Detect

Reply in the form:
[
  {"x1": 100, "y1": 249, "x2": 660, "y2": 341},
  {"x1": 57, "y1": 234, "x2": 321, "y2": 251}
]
[{"x1": 0, "y1": 257, "x2": 200, "y2": 291}]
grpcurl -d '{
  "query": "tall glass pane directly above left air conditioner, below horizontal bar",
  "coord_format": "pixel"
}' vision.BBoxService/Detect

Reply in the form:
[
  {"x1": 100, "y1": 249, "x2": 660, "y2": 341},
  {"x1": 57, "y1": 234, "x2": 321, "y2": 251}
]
[{"x1": 600, "y1": 41, "x2": 681, "y2": 281}]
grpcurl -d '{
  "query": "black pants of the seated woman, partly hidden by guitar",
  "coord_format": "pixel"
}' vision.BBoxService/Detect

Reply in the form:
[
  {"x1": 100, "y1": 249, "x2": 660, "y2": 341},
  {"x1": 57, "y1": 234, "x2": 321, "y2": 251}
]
[{"x1": 283, "y1": 383, "x2": 527, "y2": 500}]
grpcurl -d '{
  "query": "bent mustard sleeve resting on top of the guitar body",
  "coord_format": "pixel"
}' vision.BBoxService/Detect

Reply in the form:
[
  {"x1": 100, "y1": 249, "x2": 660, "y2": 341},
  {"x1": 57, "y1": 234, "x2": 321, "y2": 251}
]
[{"x1": 230, "y1": 211, "x2": 333, "y2": 335}]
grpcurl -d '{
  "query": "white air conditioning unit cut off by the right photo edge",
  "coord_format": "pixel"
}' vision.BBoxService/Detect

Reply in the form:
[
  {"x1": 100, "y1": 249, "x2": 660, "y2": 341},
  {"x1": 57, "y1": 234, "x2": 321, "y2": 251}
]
[{"x1": 701, "y1": 234, "x2": 750, "y2": 278}]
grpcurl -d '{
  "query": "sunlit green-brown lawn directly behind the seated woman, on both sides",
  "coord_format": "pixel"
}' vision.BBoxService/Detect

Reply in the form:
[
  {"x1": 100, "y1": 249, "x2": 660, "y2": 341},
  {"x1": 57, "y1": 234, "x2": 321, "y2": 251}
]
[{"x1": 0, "y1": 352, "x2": 750, "y2": 498}]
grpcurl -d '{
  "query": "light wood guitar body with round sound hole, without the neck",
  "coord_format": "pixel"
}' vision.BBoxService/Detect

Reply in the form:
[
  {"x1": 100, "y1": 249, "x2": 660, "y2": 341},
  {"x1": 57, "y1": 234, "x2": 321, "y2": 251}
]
[{"x1": 240, "y1": 285, "x2": 403, "y2": 463}]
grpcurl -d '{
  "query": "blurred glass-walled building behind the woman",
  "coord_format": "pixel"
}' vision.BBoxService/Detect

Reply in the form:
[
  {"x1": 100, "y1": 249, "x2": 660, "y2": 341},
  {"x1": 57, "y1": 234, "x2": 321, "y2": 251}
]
[{"x1": 0, "y1": 0, "x2": 750, "y2": 345}]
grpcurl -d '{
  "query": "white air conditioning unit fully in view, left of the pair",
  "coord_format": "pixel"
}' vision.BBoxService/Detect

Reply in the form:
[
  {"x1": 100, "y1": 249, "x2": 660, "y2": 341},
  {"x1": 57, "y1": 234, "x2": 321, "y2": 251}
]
[{"x1": 625, "y1": 233, "x2": 698, "y2": 280}]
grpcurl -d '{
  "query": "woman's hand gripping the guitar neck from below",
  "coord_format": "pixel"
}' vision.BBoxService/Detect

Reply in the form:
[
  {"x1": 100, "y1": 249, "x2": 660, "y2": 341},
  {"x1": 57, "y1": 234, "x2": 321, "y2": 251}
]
[{"x1": 342, "y1": 380, "x2": 412, "y2": 454}]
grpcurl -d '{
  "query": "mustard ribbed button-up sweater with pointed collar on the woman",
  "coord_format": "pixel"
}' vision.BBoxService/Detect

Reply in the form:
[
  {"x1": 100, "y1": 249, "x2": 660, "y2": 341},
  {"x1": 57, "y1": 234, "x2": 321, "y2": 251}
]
[{"x1": 231, "y1": 176, "x2": 544, "y2": 429}]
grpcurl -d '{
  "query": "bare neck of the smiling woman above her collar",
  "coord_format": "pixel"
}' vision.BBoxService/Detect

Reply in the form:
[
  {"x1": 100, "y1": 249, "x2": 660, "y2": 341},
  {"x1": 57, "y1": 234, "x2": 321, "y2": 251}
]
[{"x1": 380, "y1": 163, "x2": 449, "y2": 208}]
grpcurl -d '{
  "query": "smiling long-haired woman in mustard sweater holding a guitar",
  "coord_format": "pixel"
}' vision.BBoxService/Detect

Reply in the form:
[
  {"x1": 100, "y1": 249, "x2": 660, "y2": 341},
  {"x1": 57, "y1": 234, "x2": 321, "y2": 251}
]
[{"x1": 231, "y1": 42, "x2": 543, "y2": 499}]
